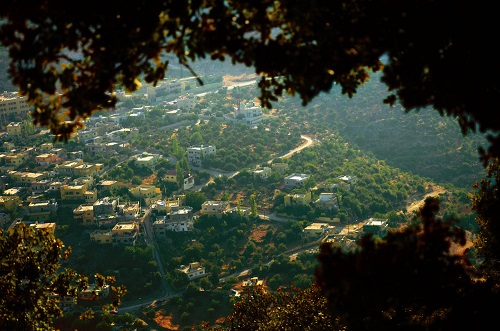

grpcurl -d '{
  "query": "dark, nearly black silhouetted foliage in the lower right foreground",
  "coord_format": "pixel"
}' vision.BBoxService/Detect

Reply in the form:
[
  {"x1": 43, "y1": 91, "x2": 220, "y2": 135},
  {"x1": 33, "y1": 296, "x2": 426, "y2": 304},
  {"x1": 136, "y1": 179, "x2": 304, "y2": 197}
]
[{"x1": 316, "y1": 198, "x2": 499, "y2": 330}]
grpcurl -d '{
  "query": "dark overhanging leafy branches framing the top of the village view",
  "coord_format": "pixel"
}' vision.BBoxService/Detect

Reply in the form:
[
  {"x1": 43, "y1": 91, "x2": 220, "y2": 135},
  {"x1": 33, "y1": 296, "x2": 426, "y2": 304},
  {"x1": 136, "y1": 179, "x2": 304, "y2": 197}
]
[{"x1": 0, "y1": 0, "x2": 500, "y2": 160}]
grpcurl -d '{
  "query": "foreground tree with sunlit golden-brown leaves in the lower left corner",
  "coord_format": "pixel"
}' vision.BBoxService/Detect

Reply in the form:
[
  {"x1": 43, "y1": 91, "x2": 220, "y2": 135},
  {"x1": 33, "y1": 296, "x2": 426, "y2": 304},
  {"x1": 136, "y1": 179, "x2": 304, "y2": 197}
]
[{"x1": 0, "y1": 223, "x2": 124, "y2": 330}]
